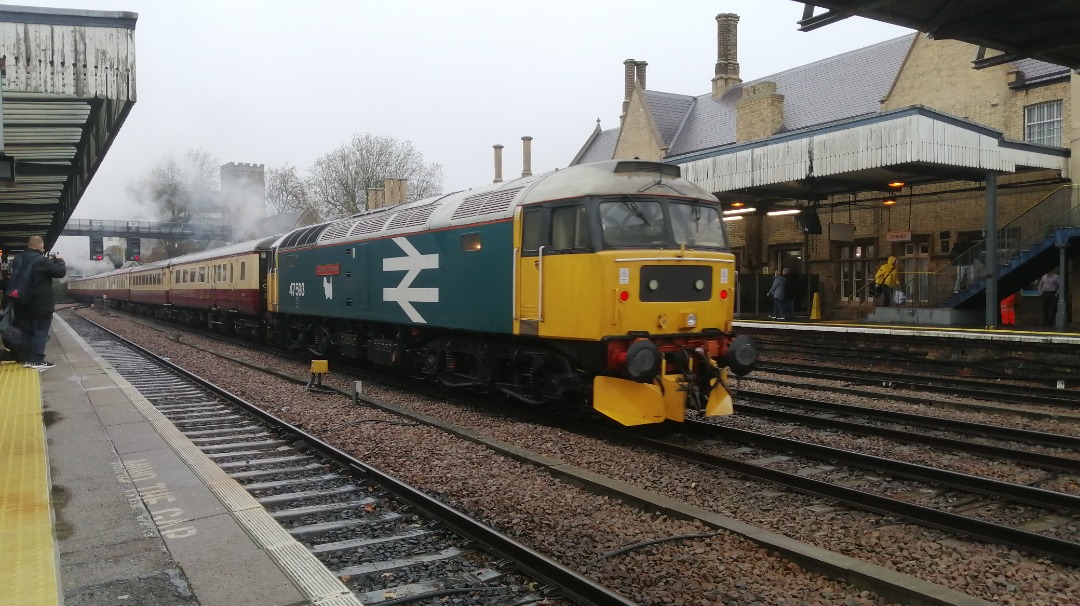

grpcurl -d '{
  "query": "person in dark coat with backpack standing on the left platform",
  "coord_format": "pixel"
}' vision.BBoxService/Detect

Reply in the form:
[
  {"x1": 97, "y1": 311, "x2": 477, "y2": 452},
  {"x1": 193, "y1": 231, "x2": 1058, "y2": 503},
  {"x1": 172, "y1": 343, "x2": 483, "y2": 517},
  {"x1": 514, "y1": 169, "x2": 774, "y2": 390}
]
[{"x1": 11, "y1": 235, "x2": 67, "y2": 371}]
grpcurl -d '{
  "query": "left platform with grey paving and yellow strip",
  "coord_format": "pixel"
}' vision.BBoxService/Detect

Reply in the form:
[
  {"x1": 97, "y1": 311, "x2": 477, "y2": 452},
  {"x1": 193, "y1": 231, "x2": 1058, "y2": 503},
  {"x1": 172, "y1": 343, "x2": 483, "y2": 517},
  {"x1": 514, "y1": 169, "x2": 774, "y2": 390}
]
[{"x1": 0, "y1": 317, "x2": 359, "y2": 606}]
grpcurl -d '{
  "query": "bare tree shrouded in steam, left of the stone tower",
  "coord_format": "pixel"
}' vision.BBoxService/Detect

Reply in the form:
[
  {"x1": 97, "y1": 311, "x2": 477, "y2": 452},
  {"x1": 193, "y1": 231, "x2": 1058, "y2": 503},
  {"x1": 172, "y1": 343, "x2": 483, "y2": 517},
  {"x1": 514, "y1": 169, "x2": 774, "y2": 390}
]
[{"x1": 127, "y1": 149, "x2": 220, "y2": 260}]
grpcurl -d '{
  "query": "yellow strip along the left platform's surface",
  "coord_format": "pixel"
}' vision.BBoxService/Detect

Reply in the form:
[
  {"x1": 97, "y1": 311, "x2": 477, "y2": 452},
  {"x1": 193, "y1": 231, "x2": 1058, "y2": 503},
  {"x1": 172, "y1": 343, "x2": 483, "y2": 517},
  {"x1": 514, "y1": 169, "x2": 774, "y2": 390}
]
[{"x1": 0, "y1": 363, "x2": 59, "y2": 606}]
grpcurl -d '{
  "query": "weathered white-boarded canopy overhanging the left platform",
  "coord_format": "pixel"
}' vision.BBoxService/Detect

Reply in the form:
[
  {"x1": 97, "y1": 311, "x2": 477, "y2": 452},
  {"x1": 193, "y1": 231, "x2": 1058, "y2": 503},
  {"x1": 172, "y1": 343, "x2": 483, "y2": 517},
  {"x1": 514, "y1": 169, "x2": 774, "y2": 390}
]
[{"x1": 0, "y1": 5, "x2": 138, "y2": 255}]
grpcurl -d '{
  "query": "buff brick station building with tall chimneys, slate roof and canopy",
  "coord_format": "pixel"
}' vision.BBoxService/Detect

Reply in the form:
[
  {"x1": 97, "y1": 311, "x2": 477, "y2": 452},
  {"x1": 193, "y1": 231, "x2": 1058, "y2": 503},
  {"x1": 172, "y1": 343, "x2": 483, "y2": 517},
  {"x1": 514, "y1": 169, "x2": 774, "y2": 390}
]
[{"x1": 571, "y1": 14, "x2": 1080, "y2": 327}]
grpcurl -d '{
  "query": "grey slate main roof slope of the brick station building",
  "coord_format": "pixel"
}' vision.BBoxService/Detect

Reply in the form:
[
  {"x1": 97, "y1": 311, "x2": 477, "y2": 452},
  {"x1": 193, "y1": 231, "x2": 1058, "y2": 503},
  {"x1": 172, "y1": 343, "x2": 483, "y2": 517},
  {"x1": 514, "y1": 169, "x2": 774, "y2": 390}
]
[{"x1": 669, "y1": 33, "x2": 917, "y2": 156}]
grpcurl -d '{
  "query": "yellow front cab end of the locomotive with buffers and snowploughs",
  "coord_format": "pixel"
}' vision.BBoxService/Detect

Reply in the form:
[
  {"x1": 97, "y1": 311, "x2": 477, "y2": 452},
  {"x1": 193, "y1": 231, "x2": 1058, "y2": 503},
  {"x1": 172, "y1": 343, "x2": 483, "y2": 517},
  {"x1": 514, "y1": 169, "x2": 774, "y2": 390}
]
[{"x1": 515, "y1": 161, "x2": 756, "y2": 425}]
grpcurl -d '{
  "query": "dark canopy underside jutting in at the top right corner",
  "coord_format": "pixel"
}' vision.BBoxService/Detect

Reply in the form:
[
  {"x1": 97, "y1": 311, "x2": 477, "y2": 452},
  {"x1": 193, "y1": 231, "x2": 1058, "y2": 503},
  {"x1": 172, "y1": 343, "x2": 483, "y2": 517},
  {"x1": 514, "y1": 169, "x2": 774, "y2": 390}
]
[{"x1": 795, "y1": 0, "x2": 1080, "y2": 69}]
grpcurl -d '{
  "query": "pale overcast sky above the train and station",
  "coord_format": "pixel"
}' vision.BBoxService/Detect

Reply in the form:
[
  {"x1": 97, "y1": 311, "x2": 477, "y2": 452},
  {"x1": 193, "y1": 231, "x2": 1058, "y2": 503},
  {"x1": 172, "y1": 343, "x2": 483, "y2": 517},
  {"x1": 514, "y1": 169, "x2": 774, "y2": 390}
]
[{"x1": 42, "y1": 0, "x2": 907, "y2": 256}]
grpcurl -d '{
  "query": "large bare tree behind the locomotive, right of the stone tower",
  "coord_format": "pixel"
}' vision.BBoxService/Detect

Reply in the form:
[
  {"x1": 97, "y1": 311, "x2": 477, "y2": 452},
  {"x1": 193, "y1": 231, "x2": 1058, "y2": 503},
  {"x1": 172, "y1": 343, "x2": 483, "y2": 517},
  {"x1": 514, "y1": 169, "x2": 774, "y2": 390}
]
[{"x1": 307, "y1": 133, "x2": 443, "y2": 218}]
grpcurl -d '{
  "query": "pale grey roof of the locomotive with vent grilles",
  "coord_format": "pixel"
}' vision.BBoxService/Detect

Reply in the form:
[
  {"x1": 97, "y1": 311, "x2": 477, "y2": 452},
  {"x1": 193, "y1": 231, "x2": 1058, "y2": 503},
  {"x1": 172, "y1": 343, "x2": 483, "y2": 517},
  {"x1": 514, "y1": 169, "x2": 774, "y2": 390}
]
[{"x1": 287, "y1": 160, "x2": 717, "y2": 248}]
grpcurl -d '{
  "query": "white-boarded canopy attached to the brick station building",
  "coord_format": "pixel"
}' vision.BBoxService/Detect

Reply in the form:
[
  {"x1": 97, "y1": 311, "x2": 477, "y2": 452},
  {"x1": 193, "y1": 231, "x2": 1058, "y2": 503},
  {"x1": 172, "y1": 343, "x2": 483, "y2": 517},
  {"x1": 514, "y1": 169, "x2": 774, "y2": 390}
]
[{"x1": 670, "y1": 106, "x2": 1069, "y2": 206}]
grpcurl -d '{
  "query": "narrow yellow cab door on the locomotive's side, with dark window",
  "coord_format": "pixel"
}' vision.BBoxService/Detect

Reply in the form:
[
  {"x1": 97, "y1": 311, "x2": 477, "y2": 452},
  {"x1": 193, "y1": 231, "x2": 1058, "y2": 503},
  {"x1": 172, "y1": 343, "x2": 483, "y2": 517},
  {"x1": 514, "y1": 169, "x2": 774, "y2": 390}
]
[{"x1": 514, "y1": 207, "x2": 548, "y2": 335}]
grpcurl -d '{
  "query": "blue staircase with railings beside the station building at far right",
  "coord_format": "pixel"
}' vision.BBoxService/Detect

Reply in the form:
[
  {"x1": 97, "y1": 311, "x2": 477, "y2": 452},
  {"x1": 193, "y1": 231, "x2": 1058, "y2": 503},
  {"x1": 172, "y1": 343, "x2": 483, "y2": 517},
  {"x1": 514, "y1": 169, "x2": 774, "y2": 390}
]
[{"x1": 934, "y1": 186, "x2": 1080, "y2": 309}]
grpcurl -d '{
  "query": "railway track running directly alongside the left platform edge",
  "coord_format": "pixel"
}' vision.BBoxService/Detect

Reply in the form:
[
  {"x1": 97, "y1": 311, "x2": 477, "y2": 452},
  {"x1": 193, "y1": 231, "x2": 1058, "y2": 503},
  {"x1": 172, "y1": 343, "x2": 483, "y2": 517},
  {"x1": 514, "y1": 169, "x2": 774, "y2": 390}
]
[{"x1": 73, "y1": 311, "x2": 633, "y2": 606}]
